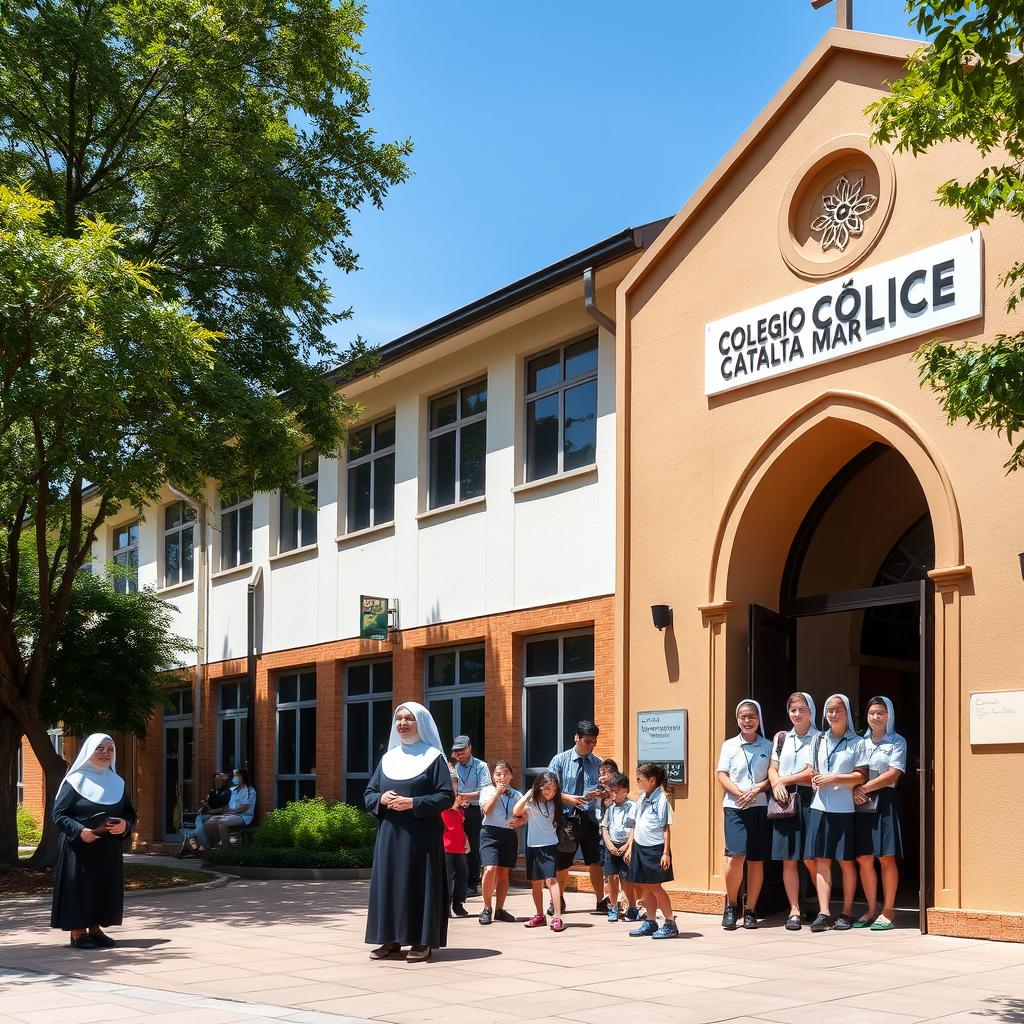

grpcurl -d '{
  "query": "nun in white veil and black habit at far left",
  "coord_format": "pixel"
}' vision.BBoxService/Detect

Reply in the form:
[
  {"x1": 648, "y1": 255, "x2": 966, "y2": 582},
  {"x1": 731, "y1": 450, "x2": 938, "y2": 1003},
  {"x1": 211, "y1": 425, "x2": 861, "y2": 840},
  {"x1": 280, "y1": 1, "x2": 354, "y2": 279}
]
[{"x1": 50, "y1": 732, "x2": 135, "y2": 949}]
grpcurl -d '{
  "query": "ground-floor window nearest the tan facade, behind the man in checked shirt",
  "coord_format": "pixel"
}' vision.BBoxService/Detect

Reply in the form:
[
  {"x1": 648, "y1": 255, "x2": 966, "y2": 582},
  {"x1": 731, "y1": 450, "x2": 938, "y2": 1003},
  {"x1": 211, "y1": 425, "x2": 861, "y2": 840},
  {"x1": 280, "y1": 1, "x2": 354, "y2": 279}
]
[{"x1": 522, "y1": 631, "x2": 594, "y2": 784}]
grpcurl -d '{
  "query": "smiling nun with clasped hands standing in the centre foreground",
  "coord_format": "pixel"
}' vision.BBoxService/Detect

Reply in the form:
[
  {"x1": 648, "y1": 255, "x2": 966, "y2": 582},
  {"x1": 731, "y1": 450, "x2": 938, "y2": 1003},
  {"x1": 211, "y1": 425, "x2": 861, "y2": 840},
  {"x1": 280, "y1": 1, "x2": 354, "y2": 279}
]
[{"x1": 365, "y1": 701, "x2": 455, "y2": 962}]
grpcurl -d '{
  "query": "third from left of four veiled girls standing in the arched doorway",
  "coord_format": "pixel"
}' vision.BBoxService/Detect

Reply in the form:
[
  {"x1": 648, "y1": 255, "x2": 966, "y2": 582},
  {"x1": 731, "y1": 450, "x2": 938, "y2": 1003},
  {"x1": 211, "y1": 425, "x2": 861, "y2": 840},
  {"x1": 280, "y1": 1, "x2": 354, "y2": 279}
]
[{"x1": 804, "y1": 693, "x2": 867, "y2": 932}]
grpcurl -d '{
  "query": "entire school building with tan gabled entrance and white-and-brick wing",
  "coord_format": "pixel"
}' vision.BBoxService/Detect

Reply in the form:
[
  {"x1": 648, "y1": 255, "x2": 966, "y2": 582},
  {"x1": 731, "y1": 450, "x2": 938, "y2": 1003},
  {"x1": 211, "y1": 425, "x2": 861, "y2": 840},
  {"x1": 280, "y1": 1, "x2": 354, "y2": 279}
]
[{"x1": 14, "y1": 29, "x2": 1024, "y2": 941}]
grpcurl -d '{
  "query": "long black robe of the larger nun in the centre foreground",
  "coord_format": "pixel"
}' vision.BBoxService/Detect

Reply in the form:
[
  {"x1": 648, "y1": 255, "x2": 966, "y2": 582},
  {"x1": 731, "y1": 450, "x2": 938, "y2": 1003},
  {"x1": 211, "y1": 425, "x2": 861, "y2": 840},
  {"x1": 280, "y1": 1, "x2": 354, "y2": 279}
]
[{"x1": 365, "y1": 757, "x2": 455, "y2": 949}]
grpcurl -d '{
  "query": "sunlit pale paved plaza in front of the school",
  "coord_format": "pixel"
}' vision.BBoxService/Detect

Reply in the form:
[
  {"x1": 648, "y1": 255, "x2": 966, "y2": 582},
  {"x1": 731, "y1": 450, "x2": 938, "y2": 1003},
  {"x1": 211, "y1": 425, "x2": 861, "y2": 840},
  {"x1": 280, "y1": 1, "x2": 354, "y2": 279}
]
[{"x1": 0, "y1": 880, "x2": 1024, "y2": 1024}]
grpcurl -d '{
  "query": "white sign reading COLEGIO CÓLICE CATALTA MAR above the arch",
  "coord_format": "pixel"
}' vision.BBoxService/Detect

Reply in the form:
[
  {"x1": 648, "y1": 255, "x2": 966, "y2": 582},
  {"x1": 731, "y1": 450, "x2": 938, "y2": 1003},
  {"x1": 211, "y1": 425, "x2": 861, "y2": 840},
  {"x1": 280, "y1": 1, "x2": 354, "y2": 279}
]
[{"x1": 705, "y1": 231, "x2": 982, "y2": 395}]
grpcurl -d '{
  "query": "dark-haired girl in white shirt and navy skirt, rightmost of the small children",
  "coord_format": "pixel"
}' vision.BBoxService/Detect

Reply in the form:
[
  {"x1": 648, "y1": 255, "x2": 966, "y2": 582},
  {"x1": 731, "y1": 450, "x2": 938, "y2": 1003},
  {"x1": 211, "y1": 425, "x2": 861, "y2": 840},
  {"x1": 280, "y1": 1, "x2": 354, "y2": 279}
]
[{"x1": 623, "y1": 764, "x2": 679, "y2": 939}]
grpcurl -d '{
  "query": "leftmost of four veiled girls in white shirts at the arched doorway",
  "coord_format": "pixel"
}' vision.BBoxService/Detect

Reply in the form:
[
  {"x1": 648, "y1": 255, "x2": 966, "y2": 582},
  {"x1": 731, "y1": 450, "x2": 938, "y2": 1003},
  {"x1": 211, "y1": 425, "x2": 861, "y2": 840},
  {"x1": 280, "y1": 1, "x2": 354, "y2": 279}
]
[{"x1": 717, "y1": 700, "x2": 771, "y2": 932}]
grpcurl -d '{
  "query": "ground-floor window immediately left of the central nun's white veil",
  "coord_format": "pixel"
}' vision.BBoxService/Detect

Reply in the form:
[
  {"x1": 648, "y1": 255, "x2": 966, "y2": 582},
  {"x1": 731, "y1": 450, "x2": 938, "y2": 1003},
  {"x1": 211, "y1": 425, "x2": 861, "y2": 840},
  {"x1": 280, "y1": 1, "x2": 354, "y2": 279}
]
[{"x1": 345, "y1": 658, "x2": 391, "y2": 807}]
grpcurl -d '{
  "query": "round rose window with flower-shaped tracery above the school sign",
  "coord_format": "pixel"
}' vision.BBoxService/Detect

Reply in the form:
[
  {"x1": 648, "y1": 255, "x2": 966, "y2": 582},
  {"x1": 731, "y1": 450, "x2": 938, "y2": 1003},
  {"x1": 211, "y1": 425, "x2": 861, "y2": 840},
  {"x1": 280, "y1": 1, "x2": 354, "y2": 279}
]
[{"x1": 778, "y1": 135, "x2": 896, "y2": 279}]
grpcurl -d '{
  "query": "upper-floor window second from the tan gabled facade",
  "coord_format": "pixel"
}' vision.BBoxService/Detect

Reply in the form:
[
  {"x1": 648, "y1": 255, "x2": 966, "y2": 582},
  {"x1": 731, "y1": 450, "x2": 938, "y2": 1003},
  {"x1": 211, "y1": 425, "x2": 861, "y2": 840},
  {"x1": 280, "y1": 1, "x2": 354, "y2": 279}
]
[{"x1": 428, "y1": 380, "x2": 487, "y2": 509}]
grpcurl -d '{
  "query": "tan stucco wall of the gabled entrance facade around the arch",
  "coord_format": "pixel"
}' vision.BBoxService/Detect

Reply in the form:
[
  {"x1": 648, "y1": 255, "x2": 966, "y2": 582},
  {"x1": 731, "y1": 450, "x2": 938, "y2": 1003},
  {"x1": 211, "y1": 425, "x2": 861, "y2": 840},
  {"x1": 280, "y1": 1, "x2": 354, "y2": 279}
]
[{"x1": 618, "y1": 37, "x2": 1024, "y2": 929}]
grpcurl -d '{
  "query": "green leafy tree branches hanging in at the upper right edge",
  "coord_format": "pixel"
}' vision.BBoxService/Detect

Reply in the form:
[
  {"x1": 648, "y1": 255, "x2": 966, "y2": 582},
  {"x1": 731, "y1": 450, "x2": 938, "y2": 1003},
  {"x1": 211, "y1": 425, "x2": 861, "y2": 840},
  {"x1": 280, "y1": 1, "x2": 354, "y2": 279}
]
[{"x1": 868, "y1": 0, "x2": 1024, "y2": 470}]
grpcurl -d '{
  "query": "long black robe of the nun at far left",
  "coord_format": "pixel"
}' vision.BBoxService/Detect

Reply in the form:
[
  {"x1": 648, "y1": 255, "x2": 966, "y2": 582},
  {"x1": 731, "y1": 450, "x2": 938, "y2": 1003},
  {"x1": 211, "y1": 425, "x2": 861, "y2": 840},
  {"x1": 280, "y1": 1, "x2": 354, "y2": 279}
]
[{"x1": 50, "y1": 782, "x2": 135, "y2": 932}]
